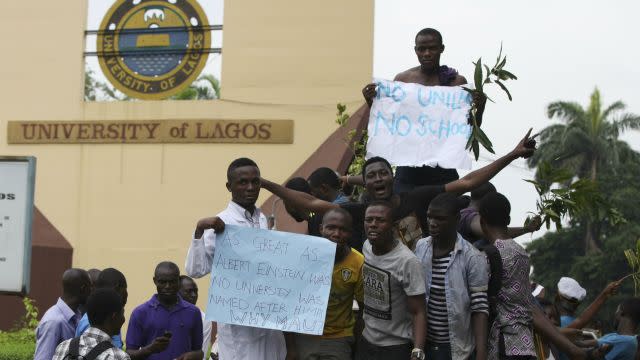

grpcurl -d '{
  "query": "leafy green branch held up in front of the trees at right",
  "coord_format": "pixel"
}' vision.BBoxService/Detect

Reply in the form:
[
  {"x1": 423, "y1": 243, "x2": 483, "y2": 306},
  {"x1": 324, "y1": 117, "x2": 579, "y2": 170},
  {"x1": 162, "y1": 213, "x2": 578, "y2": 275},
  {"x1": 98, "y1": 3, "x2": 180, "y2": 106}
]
[{"x1": 525, "y1": 162, "x2": 626, "y2": 229}]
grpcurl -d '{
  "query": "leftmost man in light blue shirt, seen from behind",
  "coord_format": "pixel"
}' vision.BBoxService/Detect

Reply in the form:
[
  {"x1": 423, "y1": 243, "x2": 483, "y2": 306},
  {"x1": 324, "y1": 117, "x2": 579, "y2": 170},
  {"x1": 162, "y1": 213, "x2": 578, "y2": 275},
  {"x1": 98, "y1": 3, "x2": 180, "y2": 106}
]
[{"x1": 34, "y1": 269, "x2": 91, "y2": 360}]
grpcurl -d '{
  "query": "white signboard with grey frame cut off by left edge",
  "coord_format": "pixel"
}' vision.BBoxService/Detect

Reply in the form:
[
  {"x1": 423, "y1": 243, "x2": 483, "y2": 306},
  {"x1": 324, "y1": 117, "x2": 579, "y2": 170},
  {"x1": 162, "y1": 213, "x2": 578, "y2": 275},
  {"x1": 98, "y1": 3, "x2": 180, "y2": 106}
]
[{"x1": 0, "y1": 157, "x2": 36, "y2": 294}]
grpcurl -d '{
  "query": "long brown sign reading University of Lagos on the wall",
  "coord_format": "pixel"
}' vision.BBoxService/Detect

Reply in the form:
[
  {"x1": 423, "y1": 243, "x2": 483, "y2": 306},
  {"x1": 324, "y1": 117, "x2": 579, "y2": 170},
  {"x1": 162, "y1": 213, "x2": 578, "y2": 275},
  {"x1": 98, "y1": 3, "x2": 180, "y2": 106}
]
[{"x1": 7, "y1": 120, "x2": 293, "y2": 144}]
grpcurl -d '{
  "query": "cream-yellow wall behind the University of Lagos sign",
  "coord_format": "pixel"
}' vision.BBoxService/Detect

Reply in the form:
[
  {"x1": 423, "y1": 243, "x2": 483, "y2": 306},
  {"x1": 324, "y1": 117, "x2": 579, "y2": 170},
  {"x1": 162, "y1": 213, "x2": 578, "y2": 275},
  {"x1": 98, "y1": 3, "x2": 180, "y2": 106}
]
[{"x1": 0, "y1": 0, "x2": 373, "y2": 326}]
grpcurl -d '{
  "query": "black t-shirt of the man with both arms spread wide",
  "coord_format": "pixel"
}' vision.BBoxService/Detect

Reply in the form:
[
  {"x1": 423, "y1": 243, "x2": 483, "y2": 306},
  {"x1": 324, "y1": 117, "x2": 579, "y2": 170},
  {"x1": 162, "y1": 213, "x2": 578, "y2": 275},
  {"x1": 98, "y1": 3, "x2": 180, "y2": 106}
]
[{"x1": 340, "y1": 185, "x2": 444, "y2": 252}]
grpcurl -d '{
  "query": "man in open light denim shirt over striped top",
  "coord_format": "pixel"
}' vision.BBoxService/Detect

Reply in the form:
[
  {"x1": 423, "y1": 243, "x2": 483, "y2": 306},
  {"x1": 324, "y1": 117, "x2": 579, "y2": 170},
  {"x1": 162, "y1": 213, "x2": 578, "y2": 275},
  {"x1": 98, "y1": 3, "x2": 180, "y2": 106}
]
[{"x1": 416, "y1": 193, "x2": 489, "y2": 360}]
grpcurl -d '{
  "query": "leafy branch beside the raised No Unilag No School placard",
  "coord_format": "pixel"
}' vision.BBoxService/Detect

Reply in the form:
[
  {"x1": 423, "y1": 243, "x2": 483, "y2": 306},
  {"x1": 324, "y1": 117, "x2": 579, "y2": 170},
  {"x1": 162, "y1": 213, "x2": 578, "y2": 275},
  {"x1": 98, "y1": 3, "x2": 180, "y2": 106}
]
[{"x1": 462, "y1": 44, "x2": 518, "y2": 160}]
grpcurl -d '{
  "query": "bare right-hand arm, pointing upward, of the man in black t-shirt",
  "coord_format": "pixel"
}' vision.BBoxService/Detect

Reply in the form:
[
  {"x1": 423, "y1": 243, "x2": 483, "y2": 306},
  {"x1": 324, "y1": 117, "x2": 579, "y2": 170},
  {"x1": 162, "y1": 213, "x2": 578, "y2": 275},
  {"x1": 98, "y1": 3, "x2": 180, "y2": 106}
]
[{"x1": 444, "y1": 129, "x2": 536, "y2": 194}]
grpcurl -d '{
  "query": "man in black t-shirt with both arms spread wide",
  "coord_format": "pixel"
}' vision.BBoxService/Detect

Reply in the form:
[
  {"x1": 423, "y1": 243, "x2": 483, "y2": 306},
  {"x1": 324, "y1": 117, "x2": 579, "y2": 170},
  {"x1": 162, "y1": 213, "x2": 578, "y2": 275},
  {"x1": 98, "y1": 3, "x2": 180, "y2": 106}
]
[{"x1": 262, "y1": 130, "x2": 535, "y2": 249}]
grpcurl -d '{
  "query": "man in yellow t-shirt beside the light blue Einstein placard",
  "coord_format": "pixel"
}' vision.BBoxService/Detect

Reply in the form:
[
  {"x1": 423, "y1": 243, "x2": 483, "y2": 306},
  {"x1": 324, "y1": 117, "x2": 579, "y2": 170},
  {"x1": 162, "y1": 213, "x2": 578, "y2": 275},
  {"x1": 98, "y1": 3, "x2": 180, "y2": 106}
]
[{"x1": 294, "y1": 209, "x2": 364, "y2": 360}]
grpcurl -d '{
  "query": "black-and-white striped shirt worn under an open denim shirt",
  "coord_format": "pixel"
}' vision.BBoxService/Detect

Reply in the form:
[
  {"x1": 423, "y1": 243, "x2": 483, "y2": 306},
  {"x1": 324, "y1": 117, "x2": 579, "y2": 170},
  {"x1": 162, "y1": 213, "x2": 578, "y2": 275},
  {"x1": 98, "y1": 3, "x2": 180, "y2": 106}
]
[{"x1": 427, "y1": 252, "x2": 489, "y2": 344}]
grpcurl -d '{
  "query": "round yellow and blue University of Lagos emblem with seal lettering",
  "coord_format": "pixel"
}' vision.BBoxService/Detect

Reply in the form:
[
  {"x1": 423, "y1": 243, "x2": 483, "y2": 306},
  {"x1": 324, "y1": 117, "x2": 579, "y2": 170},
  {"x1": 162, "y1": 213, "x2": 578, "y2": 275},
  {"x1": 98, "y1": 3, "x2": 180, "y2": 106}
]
[{"x1": 96, "y1": 0, "x2": 211, "y2": 99}]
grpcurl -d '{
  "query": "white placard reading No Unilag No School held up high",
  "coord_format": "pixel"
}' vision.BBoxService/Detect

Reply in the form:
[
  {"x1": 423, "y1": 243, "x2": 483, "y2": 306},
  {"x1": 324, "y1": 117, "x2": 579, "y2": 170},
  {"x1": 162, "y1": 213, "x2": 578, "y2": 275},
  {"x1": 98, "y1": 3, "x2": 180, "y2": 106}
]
[{"x1": 366, "y1": 79, "x2": 471, "y2": 169}]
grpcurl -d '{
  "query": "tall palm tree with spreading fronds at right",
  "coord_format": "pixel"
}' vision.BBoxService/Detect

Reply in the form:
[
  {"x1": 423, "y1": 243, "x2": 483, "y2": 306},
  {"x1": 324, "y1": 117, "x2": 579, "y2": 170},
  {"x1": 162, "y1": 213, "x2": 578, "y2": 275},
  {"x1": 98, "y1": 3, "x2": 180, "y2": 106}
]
[{"x1": 527, "y1": 88, "x2": 640, "y2": 252}]
